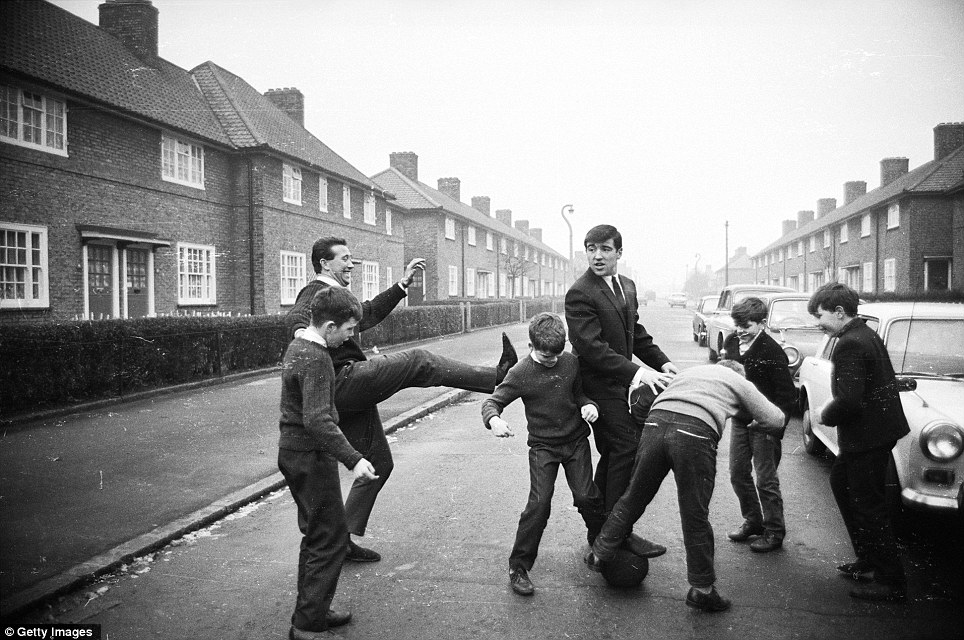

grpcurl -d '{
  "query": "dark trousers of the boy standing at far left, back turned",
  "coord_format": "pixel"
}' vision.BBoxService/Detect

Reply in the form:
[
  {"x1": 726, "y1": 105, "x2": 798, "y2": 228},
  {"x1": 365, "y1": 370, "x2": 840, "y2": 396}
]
[{"x1": 278, "y1": 449, "x2": 348, "y2": 631}]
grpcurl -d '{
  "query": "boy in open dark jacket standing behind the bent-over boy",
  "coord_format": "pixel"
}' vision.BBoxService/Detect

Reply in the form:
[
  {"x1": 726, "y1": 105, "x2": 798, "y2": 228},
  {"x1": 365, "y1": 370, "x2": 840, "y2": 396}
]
[{"x1": 723, "y1": 297, "x2": 797, "y2": 553}]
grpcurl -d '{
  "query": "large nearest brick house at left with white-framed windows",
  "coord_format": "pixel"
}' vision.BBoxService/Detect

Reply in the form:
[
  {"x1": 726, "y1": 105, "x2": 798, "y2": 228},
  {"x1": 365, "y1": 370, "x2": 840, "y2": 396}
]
[{"x1": 0, "y1": 0, "x2": 404, "y2": 323}]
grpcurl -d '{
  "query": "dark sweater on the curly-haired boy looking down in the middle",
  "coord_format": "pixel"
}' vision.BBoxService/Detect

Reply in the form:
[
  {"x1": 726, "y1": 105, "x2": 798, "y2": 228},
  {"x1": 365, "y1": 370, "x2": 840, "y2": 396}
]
[{"x1": 482, "y1": 352, "x2": 595, "y2": 447}]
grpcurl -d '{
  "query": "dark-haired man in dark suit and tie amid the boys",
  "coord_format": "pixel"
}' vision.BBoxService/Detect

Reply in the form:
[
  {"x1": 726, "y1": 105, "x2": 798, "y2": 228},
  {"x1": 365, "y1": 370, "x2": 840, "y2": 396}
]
[{"x1": 566, "y1": 224, "x2": 679, "y2": 558}]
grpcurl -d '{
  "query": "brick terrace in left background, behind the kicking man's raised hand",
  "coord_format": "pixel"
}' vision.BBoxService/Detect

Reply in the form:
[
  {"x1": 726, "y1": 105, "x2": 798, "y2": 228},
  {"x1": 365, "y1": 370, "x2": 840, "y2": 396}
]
[{"x1": 372, "y1": 152, "x2": 571, "y2": 303}]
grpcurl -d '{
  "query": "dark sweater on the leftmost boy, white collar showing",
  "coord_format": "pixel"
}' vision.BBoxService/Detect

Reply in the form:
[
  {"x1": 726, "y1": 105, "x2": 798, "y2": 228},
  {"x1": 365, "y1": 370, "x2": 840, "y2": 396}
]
[{"x1": 278, "y1": 338, "x2": 362, "y2": 469}]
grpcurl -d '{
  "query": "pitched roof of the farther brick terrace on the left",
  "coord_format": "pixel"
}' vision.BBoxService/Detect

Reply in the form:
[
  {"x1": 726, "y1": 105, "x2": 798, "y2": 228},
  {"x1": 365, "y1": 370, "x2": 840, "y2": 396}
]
[{"x1": 372, "y1": 167, "x2": 565, "y2": 258}]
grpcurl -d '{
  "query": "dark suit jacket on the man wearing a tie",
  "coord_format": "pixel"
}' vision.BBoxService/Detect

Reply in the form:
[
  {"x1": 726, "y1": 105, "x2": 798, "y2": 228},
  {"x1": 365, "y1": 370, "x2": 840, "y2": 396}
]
[{"x1": 566, "y1": 269, "x2": 670, "y2": 399}]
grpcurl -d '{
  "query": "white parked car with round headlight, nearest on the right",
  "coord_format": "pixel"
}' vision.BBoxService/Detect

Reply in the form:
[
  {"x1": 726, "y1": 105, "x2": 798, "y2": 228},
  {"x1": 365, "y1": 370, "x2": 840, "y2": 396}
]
[{"x1": 800, "y1": 302, "x2": 964, "y2": 514}]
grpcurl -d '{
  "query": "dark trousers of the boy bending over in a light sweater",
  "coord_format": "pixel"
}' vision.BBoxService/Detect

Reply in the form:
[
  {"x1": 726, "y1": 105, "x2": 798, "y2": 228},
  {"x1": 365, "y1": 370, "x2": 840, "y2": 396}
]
[{"x1": 593, "y1": 411, "x2": 719, "y2": 587}]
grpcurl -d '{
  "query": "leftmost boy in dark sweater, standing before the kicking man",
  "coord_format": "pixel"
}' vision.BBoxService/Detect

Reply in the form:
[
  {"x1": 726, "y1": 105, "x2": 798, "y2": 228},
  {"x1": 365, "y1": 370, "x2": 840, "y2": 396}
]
[{"x1": 278, "y1": 287, "x2": 378, "y2": 640}]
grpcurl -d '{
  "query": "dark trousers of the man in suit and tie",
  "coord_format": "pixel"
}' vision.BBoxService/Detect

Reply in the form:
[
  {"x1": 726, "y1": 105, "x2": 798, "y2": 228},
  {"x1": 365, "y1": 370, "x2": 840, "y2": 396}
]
[{"x1": 592, "y1": 398, "x2": 640, "y2": 512}]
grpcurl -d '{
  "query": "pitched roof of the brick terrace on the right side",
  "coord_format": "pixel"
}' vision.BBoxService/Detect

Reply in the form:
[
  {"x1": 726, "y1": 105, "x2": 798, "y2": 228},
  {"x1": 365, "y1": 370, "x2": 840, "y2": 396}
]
[{"x1": 756, "y1": 145, "x2": 964, "y2": 256}]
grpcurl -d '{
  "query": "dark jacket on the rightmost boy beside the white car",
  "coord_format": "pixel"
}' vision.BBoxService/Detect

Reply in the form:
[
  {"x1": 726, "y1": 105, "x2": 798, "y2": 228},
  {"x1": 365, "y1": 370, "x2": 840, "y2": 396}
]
[{"x1": 821, "y1": 318, "x2": 910, "y2": 452}]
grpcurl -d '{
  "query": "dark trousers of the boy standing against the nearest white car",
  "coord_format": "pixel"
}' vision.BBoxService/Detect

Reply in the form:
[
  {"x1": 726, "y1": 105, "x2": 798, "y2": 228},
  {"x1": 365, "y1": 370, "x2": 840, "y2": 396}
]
[{"x1": 830, "y1": 446, "x2": 905, "y2": 585}]
